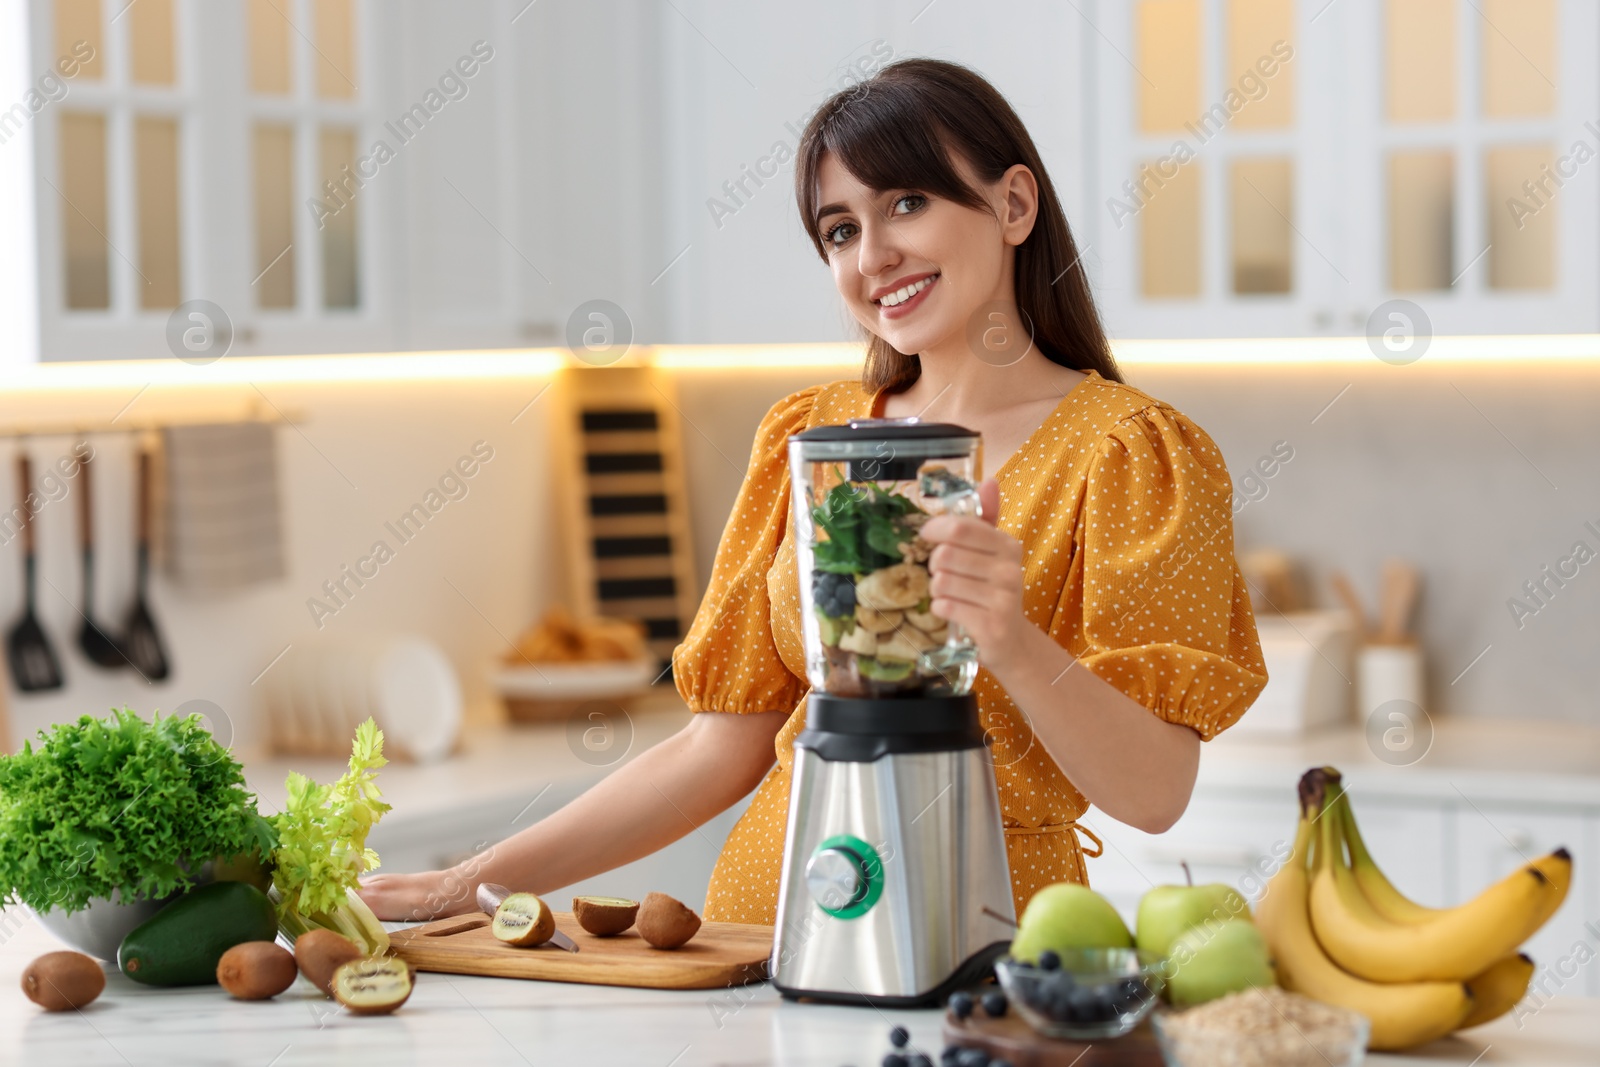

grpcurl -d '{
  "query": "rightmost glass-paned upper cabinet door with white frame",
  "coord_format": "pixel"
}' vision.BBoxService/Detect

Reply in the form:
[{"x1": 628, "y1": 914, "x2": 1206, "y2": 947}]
[{"x1": 1330, "y1": 0, "x2": 1600, "y2": 333}]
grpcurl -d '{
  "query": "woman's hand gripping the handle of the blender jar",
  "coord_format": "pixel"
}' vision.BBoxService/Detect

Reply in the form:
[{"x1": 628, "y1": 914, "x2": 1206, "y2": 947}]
[{"x1": 920, "y1": 478, "x2": 1029, "y2": 670}]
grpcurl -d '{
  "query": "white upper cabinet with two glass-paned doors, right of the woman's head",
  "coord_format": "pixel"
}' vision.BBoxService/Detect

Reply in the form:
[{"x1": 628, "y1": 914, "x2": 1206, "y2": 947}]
[{"x1": 1082, "y1": 0, "x2": 1600, "y2": 337}]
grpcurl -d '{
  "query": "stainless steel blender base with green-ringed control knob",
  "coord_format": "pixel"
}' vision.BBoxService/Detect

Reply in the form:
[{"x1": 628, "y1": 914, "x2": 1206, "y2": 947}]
[{"x1": 771, "y1": 694, "x2": 1014, "y2": 1006}]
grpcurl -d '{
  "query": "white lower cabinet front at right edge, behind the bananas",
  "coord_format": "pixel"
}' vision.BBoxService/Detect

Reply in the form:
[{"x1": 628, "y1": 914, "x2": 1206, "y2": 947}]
[{"x1": 1450, "y1": 801, "x2": 1600, "y2": 997}]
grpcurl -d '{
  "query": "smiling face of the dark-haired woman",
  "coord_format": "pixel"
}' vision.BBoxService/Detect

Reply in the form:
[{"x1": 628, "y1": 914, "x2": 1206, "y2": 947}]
[{"x1": 816, "y1": 152, "x2": 1032, "y2": 361}]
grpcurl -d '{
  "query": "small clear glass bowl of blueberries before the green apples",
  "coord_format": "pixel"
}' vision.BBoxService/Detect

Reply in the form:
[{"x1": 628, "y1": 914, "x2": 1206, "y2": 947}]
[{"x1": 995, "y1": 949, "x2": 1166, "y2": 1041}]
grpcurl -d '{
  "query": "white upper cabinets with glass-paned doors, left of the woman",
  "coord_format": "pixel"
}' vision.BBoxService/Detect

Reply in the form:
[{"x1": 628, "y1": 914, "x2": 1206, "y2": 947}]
[{"x1": 18, "y1": 0, "x2": 617, "y2": 360}]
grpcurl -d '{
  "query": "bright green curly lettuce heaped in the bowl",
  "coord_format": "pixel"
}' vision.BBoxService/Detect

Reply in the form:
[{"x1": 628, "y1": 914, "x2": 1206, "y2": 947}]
[{"x1": 0, "y1": 707, "x2": 274, "y2": 913}]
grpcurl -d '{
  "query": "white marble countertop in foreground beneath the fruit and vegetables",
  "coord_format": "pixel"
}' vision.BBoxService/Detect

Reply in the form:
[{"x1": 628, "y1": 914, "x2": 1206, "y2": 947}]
[{"x1": 0, "y1": 915, "x2": 1600, "y2": 1067}]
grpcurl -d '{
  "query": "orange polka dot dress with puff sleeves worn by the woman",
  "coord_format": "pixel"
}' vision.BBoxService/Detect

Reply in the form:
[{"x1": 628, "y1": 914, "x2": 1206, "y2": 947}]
[{"x1": 674, "y1": 371, "x2": 1267, "y2": 925}]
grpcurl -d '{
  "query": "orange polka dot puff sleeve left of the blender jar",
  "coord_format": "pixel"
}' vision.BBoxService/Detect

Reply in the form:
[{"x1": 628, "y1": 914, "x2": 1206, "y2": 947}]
[{"x1": 672, "y1": 386, "x2": 821, "y2": 713}]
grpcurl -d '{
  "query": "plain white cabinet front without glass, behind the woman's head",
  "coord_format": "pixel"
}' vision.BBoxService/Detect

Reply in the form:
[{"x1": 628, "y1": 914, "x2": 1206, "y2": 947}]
[{"x1": 654, "y1": 0, "x2": 1098, "y2": 344}]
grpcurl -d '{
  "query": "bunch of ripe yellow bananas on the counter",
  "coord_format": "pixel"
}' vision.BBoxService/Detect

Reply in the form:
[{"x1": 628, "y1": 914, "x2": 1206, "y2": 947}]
[{"x1": 1256, "y1": 768, "x2": 1571, "y2": 1049}]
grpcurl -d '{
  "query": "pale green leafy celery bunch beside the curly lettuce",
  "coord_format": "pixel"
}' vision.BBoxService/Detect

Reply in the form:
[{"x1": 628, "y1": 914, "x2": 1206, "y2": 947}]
[{"x1": 272, "y1": 718, "x2": 390, "y2": 955}]
